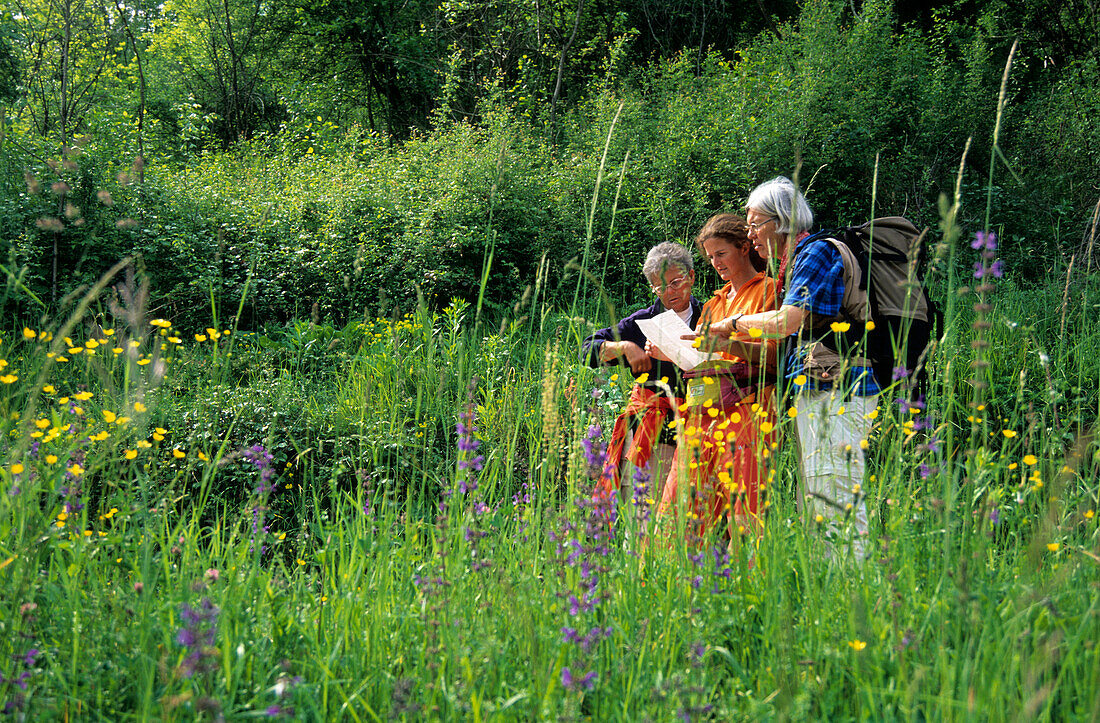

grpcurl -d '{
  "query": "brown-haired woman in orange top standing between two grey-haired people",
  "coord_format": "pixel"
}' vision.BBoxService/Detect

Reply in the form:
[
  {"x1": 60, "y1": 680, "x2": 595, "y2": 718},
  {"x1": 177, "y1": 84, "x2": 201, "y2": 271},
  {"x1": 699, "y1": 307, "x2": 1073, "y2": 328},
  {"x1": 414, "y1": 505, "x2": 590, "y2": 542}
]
[{"x1": 658, "y1": 213, "x2": 778, "y2": 547}]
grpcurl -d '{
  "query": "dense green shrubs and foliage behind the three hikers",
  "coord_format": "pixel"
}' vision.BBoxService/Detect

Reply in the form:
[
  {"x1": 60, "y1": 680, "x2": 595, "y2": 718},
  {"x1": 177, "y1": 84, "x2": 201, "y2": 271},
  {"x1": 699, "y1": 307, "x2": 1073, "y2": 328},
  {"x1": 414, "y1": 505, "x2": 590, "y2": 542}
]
[{"x1": 0, "y1": 0, "x2": 1100, "y2": 328}]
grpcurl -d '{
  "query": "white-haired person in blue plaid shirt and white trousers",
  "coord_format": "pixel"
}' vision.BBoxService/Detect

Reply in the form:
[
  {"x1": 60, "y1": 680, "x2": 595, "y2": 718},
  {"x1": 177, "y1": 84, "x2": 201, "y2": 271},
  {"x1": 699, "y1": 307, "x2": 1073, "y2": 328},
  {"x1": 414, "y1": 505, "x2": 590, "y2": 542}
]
[{"x1": 710, "y1": 177, "x2": 880, "y2": 555}]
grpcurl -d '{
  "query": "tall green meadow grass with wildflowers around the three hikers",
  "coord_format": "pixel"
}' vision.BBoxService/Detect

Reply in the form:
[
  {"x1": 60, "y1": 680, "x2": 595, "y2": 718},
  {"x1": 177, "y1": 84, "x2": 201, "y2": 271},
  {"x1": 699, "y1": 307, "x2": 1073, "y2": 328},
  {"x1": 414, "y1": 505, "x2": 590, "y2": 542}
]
[{"x1": 0, "y1": 244, "x2": 1100, "y2": 720}]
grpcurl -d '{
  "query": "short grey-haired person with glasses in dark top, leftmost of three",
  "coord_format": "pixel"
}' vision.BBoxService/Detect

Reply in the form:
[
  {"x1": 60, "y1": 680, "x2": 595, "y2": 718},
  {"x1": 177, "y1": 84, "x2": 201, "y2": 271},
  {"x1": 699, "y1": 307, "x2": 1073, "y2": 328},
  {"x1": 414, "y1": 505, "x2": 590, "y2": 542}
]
[{"x1": 581, "y1": 241, "x2": 703, "y2": 500}]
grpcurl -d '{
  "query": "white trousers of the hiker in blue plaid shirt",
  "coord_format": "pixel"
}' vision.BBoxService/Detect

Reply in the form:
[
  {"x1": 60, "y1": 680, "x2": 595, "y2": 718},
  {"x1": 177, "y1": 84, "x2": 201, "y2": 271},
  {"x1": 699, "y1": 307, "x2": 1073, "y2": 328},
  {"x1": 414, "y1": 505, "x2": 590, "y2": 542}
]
[{"x1": 795, "y1": 390, "x2": 878, "y2": 558}]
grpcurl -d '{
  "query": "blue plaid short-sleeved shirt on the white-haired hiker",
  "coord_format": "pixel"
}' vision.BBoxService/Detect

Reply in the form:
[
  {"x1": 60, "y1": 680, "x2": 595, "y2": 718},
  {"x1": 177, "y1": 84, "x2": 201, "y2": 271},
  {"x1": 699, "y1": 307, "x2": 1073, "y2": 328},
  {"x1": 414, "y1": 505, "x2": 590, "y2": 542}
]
[{"x1": 783, "y1": 237, "x2": 881, "y2": 396}]
